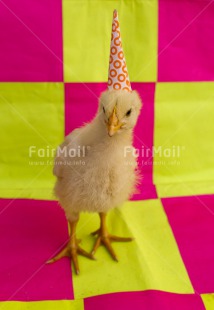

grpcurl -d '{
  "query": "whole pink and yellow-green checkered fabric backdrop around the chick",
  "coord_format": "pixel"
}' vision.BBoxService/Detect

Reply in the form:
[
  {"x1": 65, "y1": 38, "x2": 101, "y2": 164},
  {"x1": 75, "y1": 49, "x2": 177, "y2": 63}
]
[{"x1": 0, "y1": 0, "x2": 214, "y2": 310}]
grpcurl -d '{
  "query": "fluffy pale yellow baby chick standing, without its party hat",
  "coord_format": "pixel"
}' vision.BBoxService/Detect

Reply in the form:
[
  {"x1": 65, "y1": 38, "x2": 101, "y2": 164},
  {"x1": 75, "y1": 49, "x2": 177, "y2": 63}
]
[{"x1": 48, "y1": 90, "x2": 142, "y2": 274}]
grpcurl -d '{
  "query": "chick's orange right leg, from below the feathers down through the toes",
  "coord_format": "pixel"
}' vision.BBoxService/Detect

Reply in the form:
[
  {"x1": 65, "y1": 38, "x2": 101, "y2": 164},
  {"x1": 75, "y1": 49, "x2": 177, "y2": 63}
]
[{"x1": 91, "y1": 212, "x2": 133, "y2": 261}]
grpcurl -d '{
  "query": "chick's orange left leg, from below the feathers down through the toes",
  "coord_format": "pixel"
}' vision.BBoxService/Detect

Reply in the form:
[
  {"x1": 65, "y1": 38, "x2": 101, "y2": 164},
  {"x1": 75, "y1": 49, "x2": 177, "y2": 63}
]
[{"x1": 47, "y1": 219, "x2": 94, "y2": 274}]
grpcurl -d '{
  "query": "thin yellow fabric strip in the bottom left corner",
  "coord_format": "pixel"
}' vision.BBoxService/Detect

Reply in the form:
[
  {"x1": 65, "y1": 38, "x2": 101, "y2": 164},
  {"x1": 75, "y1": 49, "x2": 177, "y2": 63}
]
[{"x1": 0, "y1": 300, "x2": 84, "y2": 310}]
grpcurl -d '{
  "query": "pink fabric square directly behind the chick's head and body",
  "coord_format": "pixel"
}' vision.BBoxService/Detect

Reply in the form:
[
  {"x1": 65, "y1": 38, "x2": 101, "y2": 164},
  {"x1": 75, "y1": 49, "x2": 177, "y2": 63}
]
[{"x1": 65, "y1": 83, "x2": 157, "y2": 200}]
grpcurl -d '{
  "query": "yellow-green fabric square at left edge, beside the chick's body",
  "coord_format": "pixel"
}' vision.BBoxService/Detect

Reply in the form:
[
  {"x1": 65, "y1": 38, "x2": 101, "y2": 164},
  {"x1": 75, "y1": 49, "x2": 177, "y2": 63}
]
[{"x1": 0, "y1": 83, "x2": 64, "y2": 199}]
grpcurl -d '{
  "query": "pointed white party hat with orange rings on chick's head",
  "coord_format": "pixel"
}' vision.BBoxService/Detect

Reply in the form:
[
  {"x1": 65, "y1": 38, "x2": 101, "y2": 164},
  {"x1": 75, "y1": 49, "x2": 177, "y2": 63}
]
[{"x1": 108, "y1": 10, "x2": 132, "y2": 92}]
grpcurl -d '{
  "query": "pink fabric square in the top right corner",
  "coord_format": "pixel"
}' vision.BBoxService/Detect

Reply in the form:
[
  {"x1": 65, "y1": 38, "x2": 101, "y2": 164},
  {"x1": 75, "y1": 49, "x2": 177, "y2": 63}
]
[{"x1": 158, "y1": 0, "x2": 214, "y2": 81}]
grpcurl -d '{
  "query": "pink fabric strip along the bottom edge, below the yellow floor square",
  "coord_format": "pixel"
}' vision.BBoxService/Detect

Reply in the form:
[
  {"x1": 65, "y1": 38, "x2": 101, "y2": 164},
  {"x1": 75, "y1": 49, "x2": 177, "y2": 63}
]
[{"x1": 84, "y1": 291, "x2": 205, "y2": 310}]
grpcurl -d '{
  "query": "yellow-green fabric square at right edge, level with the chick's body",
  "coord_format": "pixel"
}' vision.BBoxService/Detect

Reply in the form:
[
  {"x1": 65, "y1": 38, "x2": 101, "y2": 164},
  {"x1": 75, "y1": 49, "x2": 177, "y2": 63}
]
[{"x1": 154, "y1": 82, "x2": 214, "y2": 197}]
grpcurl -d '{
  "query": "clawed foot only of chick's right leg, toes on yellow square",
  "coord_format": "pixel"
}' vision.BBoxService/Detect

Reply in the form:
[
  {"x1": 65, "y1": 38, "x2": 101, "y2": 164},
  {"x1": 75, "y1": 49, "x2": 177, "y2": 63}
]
[{"x1": 91, "y1": 229, "x2": 134, "y2": 262}]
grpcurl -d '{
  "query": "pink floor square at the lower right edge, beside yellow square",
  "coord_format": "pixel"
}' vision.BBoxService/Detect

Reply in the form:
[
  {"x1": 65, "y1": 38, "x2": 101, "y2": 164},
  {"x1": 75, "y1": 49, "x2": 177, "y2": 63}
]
[{"x1": 162, "y1": 195, "x2": 214, "y2": 293}]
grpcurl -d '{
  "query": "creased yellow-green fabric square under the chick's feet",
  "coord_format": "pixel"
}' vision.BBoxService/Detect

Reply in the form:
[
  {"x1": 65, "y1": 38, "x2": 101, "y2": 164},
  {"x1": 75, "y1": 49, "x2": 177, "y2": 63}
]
[{"x1": 73, "y1": 200, "x2": 193, "y2": 299}]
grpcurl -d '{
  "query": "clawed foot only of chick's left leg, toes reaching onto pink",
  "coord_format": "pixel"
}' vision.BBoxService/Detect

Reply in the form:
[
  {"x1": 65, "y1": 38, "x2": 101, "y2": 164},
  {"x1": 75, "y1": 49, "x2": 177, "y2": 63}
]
[{"x1": 46, "y1": 240, "x2": 95, "y2": 275}]
